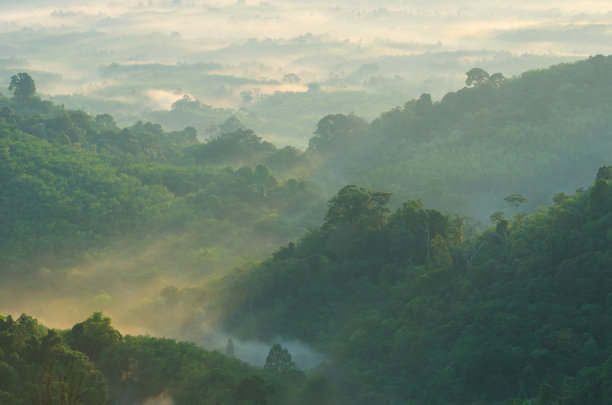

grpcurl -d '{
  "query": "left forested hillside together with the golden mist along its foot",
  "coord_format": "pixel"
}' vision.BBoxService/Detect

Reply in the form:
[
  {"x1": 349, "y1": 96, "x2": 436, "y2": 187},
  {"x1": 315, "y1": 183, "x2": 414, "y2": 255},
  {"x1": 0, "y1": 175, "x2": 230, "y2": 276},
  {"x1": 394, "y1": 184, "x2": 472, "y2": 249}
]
[{"x1": 0, "y1": 90, "x2": 321, "y2": 336}]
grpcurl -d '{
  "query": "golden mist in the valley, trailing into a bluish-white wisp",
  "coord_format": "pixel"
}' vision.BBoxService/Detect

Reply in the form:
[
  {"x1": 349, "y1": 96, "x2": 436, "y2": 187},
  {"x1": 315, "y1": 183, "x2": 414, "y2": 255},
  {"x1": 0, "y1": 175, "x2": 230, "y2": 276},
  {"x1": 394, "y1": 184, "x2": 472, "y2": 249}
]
[{"x1": 0, "y1": 224, "x2": 323, "y2": 372}]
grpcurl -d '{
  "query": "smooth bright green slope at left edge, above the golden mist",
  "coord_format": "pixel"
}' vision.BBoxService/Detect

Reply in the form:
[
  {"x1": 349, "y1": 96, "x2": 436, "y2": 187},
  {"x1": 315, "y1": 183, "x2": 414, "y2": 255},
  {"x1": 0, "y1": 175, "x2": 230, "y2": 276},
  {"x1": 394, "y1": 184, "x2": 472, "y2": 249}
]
[{"x1": 0, "y1": 123, "x2": 172, "y2": 264}]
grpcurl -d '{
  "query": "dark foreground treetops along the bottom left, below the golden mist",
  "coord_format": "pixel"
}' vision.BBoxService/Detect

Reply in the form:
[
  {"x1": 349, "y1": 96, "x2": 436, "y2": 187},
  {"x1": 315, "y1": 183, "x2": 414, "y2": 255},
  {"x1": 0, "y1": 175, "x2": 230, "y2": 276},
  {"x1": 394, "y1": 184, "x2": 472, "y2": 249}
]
[{"x1": 0, "y1": 312, "x2": 325, "y2": 405}]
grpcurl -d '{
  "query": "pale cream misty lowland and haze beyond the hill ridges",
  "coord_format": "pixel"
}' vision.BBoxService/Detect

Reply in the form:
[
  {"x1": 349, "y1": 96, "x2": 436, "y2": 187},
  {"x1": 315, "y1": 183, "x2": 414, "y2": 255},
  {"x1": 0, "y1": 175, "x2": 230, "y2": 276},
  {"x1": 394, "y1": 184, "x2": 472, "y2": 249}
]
[{"x1": 0, "y1": 0, "x2": 612, "y2": 124}]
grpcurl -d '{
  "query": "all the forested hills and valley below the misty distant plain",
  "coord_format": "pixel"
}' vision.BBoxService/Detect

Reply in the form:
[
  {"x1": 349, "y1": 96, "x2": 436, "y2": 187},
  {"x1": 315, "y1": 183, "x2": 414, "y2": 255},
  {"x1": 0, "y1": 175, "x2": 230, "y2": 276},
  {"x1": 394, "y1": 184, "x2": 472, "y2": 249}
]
[{"x1": 0, "y1": 55, "x2": 612, "y2": 405}]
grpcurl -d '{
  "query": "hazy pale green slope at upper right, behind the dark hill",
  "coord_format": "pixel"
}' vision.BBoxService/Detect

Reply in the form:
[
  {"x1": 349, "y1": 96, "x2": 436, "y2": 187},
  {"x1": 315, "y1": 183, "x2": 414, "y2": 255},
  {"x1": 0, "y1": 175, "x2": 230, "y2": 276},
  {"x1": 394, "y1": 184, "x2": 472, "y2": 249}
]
[{"x1": 310, "y1": 56, "x2": 612, "y2": 218}]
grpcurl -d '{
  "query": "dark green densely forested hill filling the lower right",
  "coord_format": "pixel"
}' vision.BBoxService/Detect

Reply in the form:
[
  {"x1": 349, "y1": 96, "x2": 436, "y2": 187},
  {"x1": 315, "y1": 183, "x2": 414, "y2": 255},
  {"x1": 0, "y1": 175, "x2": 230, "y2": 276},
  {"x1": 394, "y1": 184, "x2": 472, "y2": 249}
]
[{"x1": 207, "y1": 167, "x2": 612, "y2": 404}]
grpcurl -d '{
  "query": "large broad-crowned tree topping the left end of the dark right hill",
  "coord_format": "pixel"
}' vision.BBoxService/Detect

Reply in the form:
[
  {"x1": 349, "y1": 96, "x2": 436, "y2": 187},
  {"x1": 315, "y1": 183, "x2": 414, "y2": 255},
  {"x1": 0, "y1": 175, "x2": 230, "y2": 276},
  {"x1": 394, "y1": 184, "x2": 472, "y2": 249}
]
[{"x1": 324, "y1": 184, "x2": 391, "y2": 230}]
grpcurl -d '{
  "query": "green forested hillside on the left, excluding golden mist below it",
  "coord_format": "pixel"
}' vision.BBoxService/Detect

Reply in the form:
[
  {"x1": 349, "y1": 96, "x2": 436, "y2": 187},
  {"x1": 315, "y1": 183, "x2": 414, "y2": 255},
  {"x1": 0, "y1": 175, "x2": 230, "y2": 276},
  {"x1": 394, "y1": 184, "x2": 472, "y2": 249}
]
[{"x1": 0, "y1": 81, "x2": 320, "y2": 273}]
